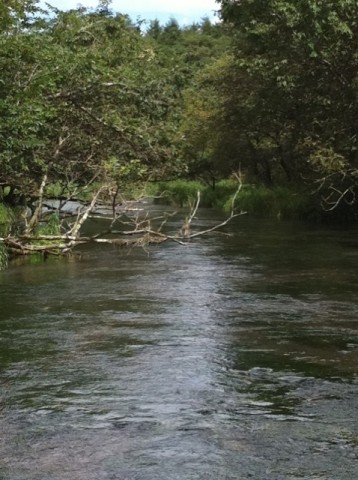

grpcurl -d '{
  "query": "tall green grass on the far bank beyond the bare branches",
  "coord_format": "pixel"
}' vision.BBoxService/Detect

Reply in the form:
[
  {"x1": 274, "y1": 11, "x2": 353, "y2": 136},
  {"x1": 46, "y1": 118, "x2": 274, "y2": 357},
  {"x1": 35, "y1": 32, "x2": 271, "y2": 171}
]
[{"x1": 152, "y1": 180, "x2": 314, "y2": 219}]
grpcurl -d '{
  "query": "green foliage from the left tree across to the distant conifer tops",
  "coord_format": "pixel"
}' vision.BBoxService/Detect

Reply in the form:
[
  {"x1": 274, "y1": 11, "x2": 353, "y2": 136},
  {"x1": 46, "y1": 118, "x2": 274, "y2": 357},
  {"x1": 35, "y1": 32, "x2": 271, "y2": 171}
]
[{"x1": 0, "y1": 0, "x2": 228, "y2": 212}]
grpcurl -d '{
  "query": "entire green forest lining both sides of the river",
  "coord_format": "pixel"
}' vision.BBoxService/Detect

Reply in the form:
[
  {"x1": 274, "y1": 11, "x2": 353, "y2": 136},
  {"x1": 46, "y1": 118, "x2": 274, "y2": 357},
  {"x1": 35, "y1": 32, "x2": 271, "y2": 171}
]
[{"x1": 0, "y1": 0, "x2": 358, "y2": 262}]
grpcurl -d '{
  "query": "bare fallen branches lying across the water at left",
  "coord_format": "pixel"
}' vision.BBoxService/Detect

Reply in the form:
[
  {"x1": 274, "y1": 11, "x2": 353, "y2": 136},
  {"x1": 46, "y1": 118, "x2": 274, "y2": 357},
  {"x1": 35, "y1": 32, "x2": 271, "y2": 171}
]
[{"x1": 0, "y1": 176, "x2": 245, "y2": 256}]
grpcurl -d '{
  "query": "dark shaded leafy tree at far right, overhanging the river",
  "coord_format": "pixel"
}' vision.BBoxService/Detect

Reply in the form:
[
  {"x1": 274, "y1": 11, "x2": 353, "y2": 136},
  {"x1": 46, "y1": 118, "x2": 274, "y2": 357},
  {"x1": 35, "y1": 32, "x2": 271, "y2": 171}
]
[{"x1": 214, "y1": 0, "x2": 358, "y2": 210}]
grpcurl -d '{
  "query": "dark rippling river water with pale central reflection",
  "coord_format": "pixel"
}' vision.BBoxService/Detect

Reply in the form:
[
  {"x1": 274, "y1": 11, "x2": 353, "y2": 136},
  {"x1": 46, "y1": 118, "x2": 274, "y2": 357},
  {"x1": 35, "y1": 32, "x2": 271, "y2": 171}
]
[{"x1": 0, "y1": 211, "x2": 358, "y2": 480}]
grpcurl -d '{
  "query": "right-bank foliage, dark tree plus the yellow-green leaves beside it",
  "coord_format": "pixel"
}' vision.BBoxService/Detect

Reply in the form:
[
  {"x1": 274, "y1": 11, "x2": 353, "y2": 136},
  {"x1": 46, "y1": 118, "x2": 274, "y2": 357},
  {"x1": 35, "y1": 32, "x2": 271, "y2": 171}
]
[{"x1": 183, "y1": 0, "x2": 358, "y2": 214}]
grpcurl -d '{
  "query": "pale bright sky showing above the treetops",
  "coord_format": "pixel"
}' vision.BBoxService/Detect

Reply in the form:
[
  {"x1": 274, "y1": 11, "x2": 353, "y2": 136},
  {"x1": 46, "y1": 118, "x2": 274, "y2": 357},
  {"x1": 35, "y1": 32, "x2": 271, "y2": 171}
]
[{"x1": 43, "y1": 0, "x2": 218, "y2": 25}]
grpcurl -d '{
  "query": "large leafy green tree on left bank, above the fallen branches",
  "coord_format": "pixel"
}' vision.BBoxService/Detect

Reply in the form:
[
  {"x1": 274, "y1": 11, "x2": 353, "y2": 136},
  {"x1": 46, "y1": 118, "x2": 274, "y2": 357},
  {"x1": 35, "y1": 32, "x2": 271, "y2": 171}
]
[{"x1": 0, "y1": 5, "x2": 182, "y2": 204}]
